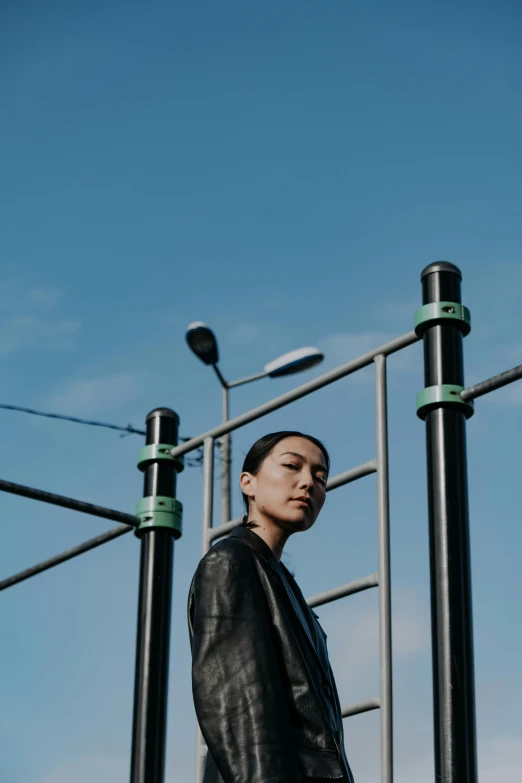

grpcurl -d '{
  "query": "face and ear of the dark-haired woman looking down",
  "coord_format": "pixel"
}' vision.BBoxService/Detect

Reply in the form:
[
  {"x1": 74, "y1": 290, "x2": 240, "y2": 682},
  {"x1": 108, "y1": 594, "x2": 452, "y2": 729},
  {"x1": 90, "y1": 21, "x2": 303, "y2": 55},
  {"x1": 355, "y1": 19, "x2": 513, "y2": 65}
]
[{"x1": 240, "y1": 437, "x2": 327, "y2": 532}]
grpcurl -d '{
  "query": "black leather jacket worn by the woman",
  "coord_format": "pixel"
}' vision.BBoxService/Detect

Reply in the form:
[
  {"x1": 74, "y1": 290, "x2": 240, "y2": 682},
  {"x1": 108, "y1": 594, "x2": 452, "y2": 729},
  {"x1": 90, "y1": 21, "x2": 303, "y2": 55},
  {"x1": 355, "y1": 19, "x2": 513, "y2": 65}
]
[{"x1": 188, "y1": 526, "x2": 353, "y2": 783}]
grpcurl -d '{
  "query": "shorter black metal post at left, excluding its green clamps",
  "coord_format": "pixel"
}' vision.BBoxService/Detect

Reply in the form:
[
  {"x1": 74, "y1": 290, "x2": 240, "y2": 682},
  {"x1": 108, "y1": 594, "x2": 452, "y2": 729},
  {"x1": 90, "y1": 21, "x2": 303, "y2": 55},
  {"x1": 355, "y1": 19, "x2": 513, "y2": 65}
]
[{"x1": 130, "y1": 408, "x2": 179, "y2": 783}]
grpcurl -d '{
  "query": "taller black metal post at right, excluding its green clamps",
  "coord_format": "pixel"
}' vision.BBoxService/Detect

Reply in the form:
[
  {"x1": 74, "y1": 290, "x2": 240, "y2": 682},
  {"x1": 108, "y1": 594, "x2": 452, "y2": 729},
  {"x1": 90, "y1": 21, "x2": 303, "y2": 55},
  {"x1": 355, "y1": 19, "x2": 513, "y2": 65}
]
[{"x1": 421, "y1": 261, "x2": 477, "y2": 783}]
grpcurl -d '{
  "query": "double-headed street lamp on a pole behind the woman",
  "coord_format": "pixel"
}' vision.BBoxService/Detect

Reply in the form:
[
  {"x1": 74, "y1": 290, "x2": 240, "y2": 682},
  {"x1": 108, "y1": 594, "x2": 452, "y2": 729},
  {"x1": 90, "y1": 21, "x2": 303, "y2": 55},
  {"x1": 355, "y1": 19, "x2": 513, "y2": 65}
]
[{"x1": 185, "y1": 321, "x2": 324, "y2": 524}]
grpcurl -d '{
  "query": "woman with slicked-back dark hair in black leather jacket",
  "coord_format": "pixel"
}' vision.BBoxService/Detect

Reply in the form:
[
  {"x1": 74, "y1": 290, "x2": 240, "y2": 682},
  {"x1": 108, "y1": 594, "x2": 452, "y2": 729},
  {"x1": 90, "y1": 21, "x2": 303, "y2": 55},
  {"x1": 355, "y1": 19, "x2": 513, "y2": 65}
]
[{"x1": 188, "y1": 431, "x2": 353, "y2": 783}]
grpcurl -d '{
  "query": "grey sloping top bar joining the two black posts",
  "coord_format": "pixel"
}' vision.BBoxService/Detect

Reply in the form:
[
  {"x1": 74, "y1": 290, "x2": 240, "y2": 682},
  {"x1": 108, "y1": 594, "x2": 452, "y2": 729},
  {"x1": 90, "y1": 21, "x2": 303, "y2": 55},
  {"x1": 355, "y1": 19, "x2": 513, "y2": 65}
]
[{"x1": 171, "y1": 332, "x2": 420, "y2": 457}]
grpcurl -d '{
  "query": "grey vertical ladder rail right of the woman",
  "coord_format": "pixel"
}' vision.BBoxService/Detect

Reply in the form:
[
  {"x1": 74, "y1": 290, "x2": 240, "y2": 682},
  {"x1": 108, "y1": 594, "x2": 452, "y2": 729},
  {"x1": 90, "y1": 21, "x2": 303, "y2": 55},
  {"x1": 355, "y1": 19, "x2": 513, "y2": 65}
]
[{"x1": 375, "y1": 355, "x2": 393, "y2": 783}]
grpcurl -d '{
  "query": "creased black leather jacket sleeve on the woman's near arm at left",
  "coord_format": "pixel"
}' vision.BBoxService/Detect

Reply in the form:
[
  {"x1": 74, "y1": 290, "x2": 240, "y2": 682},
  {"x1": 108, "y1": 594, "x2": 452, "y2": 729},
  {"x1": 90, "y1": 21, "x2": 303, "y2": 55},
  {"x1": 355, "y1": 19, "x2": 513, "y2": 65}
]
[{"x1": 188, "y1": 539, "x2": 303, "y2": 783}]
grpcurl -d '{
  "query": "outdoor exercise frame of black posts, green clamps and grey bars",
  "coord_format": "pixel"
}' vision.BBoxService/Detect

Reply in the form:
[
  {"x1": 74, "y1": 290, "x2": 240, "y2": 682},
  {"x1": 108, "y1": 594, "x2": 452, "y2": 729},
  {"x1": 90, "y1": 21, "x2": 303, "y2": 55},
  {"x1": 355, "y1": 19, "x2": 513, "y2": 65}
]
[{"x1": 0, "y1": 262, "x2": 522, "y2": 783}]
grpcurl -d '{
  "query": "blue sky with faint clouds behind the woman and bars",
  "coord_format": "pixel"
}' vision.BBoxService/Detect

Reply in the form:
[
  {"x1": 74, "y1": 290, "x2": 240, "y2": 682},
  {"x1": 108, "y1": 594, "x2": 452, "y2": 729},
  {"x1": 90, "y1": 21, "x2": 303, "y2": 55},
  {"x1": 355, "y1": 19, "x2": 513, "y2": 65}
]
[{"x1": 0, "y1": 0, "x2": 522, "y2": 783}]
